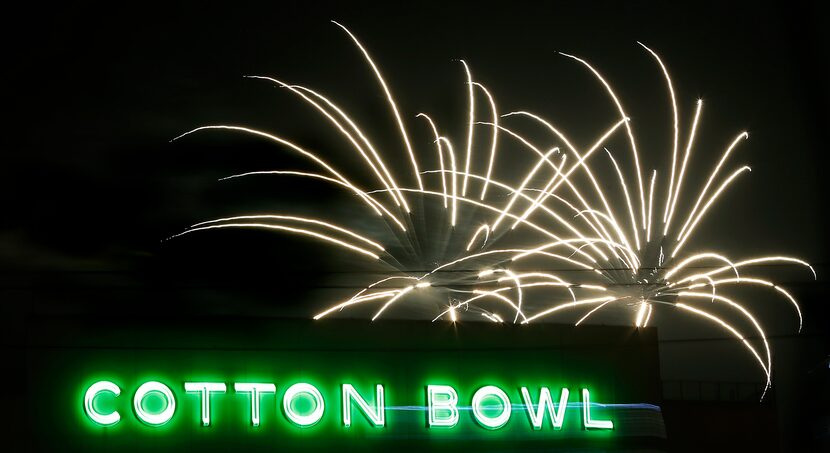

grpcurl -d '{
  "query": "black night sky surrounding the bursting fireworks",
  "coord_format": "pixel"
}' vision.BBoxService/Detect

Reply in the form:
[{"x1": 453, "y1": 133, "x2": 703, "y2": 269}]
[{"x1": 0, "y1": 2, "x2": 830, "y2": 450}]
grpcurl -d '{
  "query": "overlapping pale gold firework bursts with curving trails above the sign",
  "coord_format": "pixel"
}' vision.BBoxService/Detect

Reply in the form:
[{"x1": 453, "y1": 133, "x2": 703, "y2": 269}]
[{"x1": 171, "y1": 22, "x2": 816, "y2": 397}]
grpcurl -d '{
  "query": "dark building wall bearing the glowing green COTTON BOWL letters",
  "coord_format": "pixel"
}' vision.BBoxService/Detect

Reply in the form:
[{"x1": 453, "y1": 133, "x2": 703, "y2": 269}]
[{"x1": 27, "y1": 321, "x2": 665, "y2": 453}]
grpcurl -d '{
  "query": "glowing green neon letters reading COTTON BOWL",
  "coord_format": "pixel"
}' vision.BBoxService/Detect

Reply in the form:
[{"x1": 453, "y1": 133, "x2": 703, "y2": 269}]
[{"x1": 83, "y1": 381, "x2": 614, "y2": 430}]
